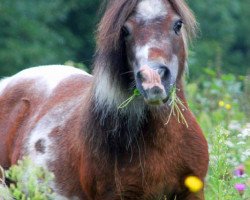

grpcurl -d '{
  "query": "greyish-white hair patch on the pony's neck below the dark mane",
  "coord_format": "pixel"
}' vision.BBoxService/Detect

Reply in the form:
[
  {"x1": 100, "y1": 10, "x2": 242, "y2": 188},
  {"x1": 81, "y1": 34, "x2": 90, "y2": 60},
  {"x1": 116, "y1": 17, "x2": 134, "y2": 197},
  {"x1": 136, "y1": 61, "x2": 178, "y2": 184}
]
[{"x1": 94, "y1": 67, "x2": 145, "y2": 124}]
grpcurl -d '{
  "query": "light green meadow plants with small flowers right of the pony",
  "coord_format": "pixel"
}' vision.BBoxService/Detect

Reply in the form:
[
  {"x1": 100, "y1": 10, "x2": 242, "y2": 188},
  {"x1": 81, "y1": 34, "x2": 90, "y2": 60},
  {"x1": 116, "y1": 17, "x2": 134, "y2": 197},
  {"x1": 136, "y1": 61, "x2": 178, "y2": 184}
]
[{"x1": 187, "y1": 68, "x2": 250, "y2": 200}]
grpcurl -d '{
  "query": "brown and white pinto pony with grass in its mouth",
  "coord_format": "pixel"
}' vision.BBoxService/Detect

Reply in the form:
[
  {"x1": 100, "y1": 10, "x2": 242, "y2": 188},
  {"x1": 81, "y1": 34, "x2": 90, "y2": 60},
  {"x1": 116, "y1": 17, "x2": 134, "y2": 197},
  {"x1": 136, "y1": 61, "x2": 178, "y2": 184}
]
[{"x1": 0, "y1": 0, "x2": 208, "y2": 200}]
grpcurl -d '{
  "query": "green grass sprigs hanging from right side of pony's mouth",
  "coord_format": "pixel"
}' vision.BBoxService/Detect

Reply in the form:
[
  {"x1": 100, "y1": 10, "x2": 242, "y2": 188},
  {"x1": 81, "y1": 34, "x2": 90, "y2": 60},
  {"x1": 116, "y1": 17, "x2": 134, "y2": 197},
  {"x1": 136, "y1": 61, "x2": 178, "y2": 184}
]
[{"x1": 165, "y1": 87, "x2": 188, "y2": 128}]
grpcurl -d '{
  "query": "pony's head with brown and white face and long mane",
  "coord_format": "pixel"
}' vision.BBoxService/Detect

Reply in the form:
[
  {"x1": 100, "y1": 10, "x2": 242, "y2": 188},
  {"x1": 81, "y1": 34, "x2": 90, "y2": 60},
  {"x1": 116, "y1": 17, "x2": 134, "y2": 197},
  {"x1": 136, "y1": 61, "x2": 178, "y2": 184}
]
[{"x1": 94, "y1": 0, "x2": 196, "y2": 108}]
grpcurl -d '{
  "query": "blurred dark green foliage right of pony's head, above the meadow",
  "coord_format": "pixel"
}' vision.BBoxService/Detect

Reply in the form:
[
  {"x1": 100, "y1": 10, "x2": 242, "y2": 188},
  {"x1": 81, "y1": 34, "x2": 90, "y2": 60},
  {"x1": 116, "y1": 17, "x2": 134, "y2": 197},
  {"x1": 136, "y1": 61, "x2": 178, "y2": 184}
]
[{"x1": 188, "y1": 0, "x2": 250, "y2": 77}]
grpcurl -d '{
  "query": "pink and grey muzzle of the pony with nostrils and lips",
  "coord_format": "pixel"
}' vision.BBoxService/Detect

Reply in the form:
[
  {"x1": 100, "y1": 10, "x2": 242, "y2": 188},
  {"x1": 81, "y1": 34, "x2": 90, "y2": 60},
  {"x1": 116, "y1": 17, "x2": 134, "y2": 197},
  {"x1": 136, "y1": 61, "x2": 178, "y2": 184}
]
[{"x1": 136, "y1": 66, "x2": 170, "y2": 105}]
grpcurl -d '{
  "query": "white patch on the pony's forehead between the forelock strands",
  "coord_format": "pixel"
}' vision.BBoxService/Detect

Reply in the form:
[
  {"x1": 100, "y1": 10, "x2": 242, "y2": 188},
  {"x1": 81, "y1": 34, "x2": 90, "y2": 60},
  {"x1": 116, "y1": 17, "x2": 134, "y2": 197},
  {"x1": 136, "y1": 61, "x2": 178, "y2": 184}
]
[{"x1": 136, "y1": 0, "x2": 167, "y2": 21}]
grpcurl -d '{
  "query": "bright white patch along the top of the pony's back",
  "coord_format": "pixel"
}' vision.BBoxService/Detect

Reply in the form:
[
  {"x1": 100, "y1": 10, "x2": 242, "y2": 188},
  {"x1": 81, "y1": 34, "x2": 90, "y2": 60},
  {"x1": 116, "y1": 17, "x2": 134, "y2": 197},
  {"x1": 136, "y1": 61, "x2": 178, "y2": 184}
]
[{"x1": 0, "y1": 65, "x2": 91, "y2": 93}]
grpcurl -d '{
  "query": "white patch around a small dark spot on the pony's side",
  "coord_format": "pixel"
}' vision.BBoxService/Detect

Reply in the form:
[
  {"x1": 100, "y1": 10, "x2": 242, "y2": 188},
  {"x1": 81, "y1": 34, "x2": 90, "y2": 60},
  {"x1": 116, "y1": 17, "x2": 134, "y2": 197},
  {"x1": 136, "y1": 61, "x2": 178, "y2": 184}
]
[{"x1": 26, "y1": 98, "x2": 82, "y2": 169}]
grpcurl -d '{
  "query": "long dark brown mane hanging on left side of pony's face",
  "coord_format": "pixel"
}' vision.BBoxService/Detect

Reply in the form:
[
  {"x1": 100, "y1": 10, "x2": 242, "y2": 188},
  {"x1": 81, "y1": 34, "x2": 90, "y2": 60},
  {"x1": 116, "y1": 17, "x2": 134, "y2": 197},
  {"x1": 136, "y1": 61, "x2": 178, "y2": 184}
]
[{"x1": 94, "y1": 0, "x2": 139, "y2": 92}]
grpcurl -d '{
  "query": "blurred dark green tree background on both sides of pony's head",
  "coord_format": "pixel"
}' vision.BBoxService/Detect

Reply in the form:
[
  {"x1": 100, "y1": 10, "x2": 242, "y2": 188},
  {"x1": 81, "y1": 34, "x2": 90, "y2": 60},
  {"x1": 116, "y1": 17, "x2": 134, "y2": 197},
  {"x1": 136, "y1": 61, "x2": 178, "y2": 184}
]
[{"x1": 0, "y1": 0, "x2": 250, "y2": 79}]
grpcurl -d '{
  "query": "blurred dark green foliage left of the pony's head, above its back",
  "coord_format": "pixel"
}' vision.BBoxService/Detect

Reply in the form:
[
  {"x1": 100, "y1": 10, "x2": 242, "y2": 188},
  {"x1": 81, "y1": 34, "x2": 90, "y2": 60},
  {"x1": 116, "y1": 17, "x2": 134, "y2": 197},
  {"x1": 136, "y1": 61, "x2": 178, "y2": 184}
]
[{"x1": 0, "y1": 0, "x2": 99, "y2": 76}]
